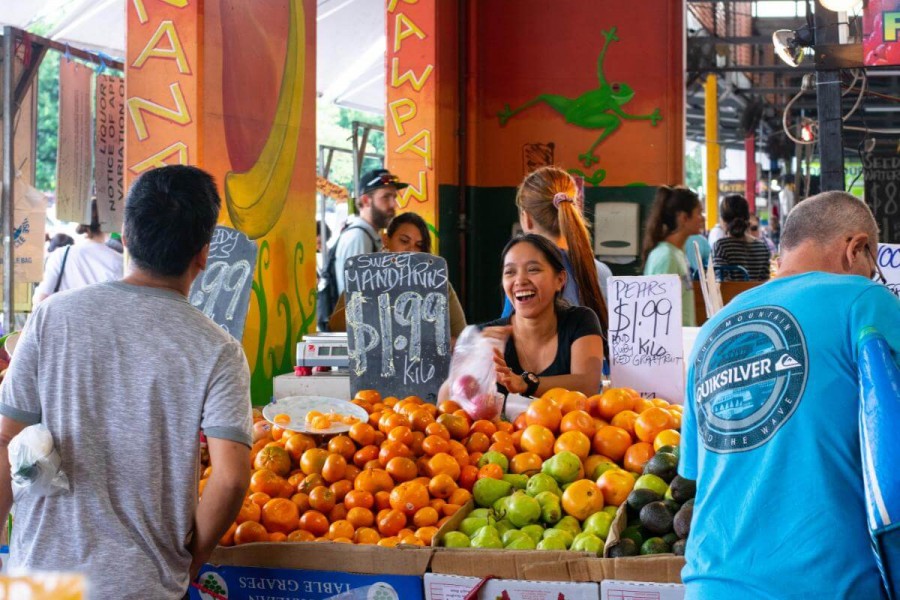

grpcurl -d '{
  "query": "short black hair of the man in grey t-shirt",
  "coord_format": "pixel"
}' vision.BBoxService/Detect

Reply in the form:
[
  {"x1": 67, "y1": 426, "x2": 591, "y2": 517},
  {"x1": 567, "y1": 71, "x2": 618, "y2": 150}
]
[{"x1": 124, "y1": 165, "x2": 221, "y2": 277}]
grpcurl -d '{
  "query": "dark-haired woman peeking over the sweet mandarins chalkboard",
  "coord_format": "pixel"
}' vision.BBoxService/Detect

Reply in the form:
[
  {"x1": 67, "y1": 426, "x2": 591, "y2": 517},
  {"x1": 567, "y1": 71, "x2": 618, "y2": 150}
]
[{"x1": 328, "y1": 213, "x2": 466, "y2": 341}]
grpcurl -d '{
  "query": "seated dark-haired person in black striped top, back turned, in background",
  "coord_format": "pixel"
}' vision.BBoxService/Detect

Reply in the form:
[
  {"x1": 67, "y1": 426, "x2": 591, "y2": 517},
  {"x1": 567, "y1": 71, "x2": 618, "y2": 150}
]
[{"x1": 713, "y1": 194, "x2": 772, "y2": 281}]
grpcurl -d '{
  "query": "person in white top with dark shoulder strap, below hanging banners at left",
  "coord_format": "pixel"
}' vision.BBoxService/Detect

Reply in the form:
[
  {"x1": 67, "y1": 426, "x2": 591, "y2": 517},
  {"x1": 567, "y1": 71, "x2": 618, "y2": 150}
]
[{"x1": 34, "y1": 202, "x2": 124, "y2": 304}]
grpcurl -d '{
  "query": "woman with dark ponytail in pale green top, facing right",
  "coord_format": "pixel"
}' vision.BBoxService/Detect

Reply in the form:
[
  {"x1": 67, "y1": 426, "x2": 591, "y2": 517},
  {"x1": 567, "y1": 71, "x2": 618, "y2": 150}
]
[{"x1": 643, "y1": 185, "x2": 703, "y2": 327}]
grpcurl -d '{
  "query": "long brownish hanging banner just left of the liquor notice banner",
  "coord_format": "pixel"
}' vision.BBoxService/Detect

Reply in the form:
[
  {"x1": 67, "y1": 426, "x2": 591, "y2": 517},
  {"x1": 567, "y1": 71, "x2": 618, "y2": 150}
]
[{"x1": 56, "y1": 60, "x2": 93, "y2": 223}]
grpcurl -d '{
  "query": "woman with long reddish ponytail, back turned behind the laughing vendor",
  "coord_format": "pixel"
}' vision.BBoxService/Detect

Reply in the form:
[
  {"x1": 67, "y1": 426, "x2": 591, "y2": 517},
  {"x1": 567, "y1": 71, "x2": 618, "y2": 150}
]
[{"x1": 503, "y1": 167, "x2": 612, "y2": 338}]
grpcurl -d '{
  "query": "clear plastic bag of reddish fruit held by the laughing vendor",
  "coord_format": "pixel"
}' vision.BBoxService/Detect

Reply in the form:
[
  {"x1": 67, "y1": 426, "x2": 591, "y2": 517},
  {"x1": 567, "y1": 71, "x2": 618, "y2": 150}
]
[{"x1": 450, "y1": 325, "x2": 503, "y2": 420}]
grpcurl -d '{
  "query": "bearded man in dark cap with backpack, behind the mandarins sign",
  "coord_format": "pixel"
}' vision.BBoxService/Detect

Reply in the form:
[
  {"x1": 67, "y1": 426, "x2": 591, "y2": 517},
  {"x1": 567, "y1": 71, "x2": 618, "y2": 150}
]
[{"x1": 334, "y1": 169, "x2": 409, "y2": 294}]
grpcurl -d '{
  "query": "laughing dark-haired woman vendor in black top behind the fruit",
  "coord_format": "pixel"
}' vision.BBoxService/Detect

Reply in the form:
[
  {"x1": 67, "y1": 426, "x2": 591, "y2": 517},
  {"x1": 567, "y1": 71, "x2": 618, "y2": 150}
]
[{"x1": 483, "y1": 234, "x2": 603, "y2": 396}]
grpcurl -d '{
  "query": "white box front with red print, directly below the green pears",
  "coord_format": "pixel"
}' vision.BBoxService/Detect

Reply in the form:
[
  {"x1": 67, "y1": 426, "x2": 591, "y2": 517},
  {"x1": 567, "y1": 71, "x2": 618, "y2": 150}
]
[{"x1": 425, "y1": 573, "x2": 600, "y2": 600}]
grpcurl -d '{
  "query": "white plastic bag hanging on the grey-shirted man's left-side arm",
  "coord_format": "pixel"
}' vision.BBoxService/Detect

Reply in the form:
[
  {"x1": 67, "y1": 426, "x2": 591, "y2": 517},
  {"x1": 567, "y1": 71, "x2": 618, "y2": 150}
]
[{"x1": 9, "y1": 424, "x2": 70, "y2": 500}]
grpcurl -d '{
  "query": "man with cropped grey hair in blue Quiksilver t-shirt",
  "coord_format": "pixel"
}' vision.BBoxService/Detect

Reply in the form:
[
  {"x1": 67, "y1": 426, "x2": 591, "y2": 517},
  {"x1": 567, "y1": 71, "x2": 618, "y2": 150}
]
[{"x1": 679, "y1": 192, "x2": 900, "y2": 599}]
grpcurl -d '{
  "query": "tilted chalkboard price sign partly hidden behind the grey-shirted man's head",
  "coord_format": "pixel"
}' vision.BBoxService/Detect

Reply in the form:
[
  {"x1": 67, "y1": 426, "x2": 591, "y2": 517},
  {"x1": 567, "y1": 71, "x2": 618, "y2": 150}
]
[{"x1": 188, "y1": 225, "x2": 257, "y2": 341}]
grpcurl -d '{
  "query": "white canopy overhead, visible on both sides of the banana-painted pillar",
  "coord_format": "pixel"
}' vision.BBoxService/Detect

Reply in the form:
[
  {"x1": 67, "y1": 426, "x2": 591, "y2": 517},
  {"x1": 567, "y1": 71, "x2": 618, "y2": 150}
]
[{"x1": 0, "y1": 0, "x2": 386, "y2": 114}]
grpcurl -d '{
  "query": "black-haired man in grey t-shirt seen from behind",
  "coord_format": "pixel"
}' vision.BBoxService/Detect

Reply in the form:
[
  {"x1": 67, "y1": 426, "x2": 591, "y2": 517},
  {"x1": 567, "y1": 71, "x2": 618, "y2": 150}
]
[{"x1": 0, "y1": 166, "x2": 251, "y2": 599}]
